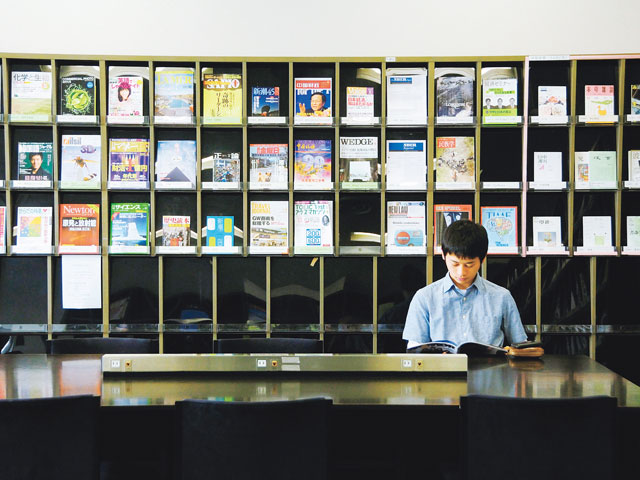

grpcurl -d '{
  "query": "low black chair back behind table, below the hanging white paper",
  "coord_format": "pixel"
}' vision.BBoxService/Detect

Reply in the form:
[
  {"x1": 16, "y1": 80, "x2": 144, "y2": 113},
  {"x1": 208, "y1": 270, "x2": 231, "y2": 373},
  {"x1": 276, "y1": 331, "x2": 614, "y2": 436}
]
[{"x1": 47, "y1": 337, "x2": 158, "y2": 355}]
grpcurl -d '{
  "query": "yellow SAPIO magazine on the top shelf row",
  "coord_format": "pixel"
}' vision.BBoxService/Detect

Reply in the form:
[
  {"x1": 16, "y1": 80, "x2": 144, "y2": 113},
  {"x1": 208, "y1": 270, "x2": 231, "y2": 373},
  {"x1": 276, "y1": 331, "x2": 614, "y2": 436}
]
[{"x1": 202, "y1": 72, "x2": 242, "y2": 121}]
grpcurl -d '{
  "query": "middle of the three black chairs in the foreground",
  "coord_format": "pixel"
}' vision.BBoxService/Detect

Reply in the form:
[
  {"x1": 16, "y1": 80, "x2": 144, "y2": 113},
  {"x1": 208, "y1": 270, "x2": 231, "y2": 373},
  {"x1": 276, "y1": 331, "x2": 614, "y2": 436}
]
[{"x1": 176, "y1": 398, "x2": 331, "y2": 480}]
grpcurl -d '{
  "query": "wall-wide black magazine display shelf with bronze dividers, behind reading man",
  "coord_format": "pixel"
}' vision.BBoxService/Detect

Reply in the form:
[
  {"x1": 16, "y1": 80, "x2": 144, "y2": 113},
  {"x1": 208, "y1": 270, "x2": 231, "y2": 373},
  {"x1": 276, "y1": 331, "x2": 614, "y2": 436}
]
[{"x1": 0, "y1": 53, "x2": 640, "y2": 358}]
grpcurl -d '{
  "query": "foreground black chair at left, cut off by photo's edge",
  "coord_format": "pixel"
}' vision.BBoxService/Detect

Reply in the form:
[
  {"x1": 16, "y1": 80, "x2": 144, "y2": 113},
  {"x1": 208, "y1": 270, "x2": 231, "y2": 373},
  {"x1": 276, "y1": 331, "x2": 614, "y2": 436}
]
[{"x1": 0, "y1": 395, "x2": 100, "y2": 480}]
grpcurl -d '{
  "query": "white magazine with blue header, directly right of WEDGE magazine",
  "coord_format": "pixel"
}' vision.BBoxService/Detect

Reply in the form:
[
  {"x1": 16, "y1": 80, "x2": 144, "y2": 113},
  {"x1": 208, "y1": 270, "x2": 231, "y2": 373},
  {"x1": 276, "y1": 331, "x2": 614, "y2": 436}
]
[{"x1": 386, "y1": 140, "x2": 427, "y2": 190}]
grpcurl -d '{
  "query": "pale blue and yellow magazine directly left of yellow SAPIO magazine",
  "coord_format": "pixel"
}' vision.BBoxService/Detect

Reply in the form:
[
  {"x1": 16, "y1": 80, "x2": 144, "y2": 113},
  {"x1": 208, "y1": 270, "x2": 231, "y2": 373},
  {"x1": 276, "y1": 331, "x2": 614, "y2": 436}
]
[{"x1": 154, "y1": 67, "x2": 194, "y2": 117}]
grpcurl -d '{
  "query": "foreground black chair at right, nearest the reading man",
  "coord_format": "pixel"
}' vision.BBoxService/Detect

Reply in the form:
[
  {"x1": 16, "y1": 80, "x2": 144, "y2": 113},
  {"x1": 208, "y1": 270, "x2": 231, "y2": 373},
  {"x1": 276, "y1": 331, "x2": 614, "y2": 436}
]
[{"x1": 460, "y1": 395, "x2": 616, "y2": 480}]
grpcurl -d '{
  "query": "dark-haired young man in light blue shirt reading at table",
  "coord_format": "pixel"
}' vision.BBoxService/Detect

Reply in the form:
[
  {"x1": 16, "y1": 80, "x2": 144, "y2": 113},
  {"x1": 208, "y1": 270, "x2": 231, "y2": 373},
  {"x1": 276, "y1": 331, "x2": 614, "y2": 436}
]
[{"x1": 402, "y1": 220, "x2": 527, "y2": 348}]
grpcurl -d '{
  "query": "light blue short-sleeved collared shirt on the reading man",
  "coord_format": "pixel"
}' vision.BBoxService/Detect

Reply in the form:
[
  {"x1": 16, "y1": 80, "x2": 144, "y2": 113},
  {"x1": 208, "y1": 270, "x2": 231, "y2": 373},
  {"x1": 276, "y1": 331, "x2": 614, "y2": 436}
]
[{"x1": 402, "y1": 273, "x2": 527, "y2": 347}]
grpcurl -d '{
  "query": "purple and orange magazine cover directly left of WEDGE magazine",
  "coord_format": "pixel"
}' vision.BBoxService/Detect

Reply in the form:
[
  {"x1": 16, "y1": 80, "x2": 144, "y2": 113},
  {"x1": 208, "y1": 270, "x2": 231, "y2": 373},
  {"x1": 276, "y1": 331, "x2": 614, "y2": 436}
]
[{"x1": 294, "y1": 140, "x2": 332, "y2": 188}]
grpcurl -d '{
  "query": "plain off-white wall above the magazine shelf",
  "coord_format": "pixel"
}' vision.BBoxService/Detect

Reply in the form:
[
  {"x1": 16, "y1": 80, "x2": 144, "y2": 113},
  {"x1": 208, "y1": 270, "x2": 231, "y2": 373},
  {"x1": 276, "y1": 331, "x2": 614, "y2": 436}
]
[{"x1": 0, "y1": 0, "x2": 640, "y2": 57}]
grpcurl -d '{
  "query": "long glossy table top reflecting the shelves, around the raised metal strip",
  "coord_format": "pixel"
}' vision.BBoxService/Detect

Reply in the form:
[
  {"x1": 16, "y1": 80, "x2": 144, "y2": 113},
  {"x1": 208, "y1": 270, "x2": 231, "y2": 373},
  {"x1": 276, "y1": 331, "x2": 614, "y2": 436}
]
[{"x1": 0, "y1": 355, "x2": 640, "y2": 407}]
